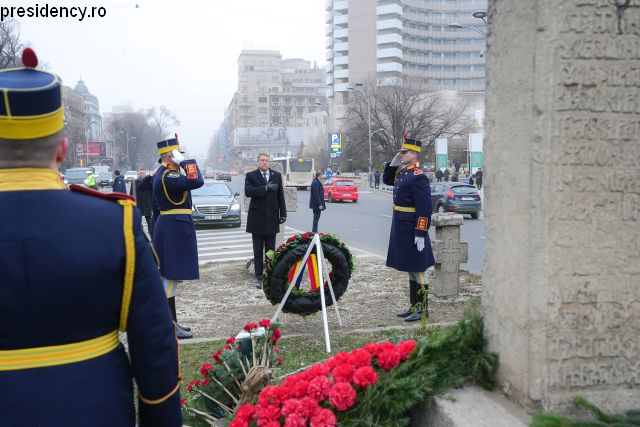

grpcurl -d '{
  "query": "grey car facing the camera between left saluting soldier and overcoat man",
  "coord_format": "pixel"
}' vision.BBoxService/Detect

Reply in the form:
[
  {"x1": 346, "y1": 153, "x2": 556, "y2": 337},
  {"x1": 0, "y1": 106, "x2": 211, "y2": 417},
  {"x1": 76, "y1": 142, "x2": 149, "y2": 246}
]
[{"x1": 191, "y1": 179, "x2": 242, "y2": 227}]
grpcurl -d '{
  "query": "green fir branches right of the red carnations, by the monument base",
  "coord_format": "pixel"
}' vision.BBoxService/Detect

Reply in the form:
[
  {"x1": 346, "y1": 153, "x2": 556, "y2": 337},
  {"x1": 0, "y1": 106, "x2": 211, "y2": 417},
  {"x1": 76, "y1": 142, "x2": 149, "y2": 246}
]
[{"x1": 336, "y1": 314, "x2": 498, "y2": 427}]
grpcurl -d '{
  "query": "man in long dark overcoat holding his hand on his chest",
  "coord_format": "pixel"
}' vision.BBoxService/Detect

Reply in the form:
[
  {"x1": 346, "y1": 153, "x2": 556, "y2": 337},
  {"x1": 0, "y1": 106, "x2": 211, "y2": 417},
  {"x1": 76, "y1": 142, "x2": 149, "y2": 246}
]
[{"x1": 244, "y1": 153, "x2": 287, "y2": 288}]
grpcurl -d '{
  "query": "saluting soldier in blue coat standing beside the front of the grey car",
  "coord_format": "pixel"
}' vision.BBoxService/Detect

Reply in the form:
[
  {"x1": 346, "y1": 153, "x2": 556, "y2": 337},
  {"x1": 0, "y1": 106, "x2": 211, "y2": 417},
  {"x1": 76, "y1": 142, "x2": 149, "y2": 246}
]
[{"x1": 153, "y1": 135, "x2": 204, "y2": 338}]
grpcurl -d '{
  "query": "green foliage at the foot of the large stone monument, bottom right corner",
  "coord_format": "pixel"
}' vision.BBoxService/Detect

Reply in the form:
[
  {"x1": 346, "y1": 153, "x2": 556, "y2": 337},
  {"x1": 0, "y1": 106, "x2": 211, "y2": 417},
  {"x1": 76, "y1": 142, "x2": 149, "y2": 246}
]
[{"x1": 530, "y1": 396, "x2": 640, "y2": 427}]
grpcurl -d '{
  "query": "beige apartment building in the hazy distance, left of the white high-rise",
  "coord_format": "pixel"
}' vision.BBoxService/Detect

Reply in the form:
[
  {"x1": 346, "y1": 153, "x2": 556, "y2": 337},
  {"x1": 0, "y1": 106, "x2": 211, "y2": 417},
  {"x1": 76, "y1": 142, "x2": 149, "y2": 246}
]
[{"x1": 221, "y1": 50, "x2": 326, "y2": 165}]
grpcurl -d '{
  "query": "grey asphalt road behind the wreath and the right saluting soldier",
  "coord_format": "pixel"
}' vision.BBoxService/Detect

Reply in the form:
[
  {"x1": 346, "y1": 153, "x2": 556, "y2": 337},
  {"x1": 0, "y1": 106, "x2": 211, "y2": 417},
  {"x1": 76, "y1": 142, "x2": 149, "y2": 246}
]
[{"x1": 231, "y1": 175, "x2": 484, "y2": 274}]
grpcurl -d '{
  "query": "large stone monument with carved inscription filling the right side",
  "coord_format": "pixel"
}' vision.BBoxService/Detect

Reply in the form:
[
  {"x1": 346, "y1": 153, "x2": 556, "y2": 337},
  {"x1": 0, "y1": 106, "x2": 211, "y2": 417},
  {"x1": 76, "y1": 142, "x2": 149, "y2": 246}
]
[{"x1": 482, "y1": 0, "x2": 640, "y2": 412}]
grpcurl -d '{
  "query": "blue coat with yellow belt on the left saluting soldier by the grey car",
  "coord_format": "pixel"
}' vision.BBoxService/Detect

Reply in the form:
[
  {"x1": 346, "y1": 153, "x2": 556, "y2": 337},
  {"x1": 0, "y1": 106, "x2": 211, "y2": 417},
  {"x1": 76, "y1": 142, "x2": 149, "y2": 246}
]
[{"x1": 153, "y1": 160, "x2": 204, "y2": 280}]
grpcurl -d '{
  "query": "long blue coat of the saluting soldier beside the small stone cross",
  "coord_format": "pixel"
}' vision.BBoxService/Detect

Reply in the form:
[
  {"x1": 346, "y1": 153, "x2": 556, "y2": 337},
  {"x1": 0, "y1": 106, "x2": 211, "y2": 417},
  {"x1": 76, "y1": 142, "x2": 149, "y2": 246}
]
[{"x1": 383, "y1": 164, "x2": 435, "y2": 273}]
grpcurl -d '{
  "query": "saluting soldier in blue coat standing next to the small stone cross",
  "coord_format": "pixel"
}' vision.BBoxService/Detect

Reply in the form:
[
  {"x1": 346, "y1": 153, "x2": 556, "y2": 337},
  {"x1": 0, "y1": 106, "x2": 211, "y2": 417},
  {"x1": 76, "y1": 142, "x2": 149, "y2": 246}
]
[{"x1": 383, "y1": 138, "x2": 435, "y2": 322}]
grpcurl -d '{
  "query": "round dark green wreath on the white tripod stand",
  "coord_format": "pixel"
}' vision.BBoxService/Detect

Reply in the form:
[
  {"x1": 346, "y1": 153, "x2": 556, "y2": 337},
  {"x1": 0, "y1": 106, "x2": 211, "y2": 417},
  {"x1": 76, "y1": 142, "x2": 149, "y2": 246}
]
[{"x1": 262, "y1": 233, "x2": 354, "y2": 315}]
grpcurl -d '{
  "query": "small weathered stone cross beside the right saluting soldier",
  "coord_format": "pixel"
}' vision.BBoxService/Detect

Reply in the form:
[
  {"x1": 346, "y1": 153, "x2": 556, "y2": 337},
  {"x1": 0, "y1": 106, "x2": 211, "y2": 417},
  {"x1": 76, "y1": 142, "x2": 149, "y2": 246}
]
[{"x1": 431, "y1": 212, "x2": 468, "y2": 297}]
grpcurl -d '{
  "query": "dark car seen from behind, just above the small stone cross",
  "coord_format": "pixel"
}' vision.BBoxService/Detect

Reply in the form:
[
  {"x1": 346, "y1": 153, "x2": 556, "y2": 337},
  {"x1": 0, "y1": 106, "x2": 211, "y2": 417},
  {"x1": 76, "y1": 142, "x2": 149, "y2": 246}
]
[{"x1": 431, "y1": 182, "x2": 482, "y2": 219}]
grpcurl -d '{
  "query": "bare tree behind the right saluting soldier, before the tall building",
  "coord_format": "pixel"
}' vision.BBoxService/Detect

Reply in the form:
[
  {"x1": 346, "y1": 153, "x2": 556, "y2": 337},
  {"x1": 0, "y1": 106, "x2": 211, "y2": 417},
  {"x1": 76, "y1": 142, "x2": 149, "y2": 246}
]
[{"x1": 346, "y1": 81, "x2": 469, "y2": 165}]
